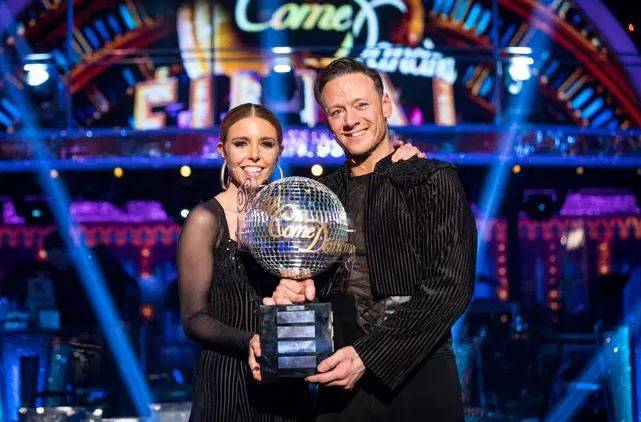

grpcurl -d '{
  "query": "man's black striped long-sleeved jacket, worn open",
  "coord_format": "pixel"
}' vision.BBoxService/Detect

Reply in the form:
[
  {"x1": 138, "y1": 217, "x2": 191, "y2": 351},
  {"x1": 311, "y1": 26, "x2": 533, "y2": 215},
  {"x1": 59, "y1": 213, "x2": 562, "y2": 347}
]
[{"x1": 320, "y1": 156, "x2": 476, "y2": 390}]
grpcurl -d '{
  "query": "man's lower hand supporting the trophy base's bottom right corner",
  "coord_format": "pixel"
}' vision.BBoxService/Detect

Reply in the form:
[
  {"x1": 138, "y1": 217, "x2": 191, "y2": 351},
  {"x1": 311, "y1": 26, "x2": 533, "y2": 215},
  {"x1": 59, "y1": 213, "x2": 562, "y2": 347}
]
[{"x1": 305, "y1": 346, "x2": 365, "y2": 390}]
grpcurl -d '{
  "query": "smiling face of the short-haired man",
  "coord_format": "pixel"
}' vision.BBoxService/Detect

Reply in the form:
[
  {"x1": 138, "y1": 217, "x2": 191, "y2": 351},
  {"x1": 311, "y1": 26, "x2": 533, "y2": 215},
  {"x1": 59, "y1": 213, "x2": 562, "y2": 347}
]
[{"x1": 322, "y1": 73, "x2": 392, "y2": 157}]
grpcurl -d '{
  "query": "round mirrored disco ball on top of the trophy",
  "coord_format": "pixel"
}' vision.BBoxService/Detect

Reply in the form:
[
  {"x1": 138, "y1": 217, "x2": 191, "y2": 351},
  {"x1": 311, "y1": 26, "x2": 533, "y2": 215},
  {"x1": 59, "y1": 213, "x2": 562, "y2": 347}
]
[{"x1": 243, "y1": 177, "x2": 348, "y2": 278}]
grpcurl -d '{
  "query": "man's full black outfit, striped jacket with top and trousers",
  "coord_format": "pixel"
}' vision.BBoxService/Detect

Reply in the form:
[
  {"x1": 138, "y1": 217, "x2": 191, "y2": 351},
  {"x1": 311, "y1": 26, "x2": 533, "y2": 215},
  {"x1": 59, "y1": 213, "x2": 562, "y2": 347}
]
[{"x1": 319, "y1": 157, "x2": 476, "y2": 422}]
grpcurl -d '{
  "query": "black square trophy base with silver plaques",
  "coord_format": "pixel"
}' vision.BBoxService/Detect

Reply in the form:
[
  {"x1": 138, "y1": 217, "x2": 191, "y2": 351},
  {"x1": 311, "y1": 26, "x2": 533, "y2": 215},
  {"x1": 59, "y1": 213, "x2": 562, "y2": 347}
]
[{"x1": 260, "y1": 303, "x2": 334, "y2": 379}]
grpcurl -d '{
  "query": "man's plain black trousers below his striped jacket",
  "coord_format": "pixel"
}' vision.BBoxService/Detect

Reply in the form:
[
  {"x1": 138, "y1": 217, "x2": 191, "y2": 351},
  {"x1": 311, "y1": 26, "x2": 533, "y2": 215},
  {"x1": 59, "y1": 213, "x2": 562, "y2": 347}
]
[{"x1": 316, "y1": 353, "x2": 464, "y2": 422}]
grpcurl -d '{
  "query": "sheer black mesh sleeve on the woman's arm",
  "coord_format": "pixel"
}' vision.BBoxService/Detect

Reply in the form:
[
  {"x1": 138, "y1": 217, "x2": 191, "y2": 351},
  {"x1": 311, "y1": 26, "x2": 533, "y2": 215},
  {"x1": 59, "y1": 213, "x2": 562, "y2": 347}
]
[{"x1": 178, "y1": 204, "x2": 253, "y2": 353}]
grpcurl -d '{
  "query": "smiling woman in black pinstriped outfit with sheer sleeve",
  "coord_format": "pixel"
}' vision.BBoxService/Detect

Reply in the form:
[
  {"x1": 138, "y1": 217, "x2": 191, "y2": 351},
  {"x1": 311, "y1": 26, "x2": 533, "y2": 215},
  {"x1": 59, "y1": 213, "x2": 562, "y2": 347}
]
[{"x1": 178, "y1": 104, "x2": 420, "y2": 421}]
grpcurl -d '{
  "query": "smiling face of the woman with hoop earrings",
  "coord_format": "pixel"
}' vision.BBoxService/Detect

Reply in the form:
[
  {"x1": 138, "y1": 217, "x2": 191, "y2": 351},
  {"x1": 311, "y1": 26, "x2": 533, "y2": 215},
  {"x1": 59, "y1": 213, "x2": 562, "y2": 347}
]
[{"x1": 218, "y1": 116, "x2": 280, "y2": 186}]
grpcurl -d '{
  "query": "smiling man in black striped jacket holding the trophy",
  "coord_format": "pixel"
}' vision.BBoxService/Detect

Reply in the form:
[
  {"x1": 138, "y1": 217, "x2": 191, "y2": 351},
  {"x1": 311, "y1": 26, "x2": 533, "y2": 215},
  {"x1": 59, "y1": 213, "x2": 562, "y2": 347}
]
[{"x1": 264, "y1": 58, "x2": 476, "y2": 422}]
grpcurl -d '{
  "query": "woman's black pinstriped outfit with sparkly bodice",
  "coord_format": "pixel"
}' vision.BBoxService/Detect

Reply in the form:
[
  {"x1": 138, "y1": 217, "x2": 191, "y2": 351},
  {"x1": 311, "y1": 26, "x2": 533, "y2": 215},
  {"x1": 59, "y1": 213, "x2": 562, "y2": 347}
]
[{"x1": 181, "y1": 200, "x2": 312, "y2": 421}]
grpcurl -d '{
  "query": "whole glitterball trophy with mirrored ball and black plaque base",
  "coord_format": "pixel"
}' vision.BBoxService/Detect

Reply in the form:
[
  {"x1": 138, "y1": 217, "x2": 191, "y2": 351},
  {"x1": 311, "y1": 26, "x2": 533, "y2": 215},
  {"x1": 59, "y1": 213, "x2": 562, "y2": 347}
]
[{"x1": 237, "y1": 177, "x2": 354, "y2": 379}]
